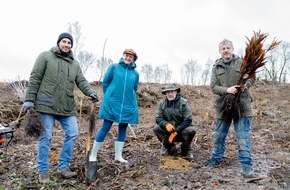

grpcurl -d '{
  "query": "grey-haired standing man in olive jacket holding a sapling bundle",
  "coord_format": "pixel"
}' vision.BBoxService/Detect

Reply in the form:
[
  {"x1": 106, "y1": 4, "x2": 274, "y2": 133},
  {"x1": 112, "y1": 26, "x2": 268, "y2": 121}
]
[{"x1": 206, "y1": 39, "x2": 254, "y2": 177}]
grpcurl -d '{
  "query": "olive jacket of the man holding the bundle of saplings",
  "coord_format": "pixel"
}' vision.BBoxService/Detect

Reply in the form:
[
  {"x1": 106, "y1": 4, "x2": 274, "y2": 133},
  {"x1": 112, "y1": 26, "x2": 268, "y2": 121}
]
[{"x1": 210, "y1": 55, "x2": 255, "y2": 119}]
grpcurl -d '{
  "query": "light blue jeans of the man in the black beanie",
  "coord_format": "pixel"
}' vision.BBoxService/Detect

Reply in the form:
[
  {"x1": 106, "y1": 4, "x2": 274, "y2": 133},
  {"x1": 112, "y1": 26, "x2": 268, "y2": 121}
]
[{"x1": 37, "y1": 113, "x2": 79, "y2": 173}]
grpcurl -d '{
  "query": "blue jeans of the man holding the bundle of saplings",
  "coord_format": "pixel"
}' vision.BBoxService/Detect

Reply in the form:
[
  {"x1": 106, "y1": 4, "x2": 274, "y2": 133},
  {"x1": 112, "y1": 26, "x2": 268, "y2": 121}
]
[{"x1": 212, "y1": 117, "x2": 252, "y2": 168}]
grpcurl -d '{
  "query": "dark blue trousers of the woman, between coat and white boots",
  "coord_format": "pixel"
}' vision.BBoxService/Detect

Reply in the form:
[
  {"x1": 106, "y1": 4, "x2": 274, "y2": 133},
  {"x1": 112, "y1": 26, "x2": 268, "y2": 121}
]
[{"x1": 95, "y1": 120, "x2": 128, "y2": 142}]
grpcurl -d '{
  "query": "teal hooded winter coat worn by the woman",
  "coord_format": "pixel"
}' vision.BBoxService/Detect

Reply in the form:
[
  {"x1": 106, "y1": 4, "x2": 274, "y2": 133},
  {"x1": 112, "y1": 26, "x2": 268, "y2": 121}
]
[{"x1": 98, "y1": 58, "x2": 139, "y2": 124}]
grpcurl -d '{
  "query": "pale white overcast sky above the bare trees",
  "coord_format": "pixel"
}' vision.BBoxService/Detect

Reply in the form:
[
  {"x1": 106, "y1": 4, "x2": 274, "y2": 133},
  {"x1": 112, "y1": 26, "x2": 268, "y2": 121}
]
[{"x1": 0, "y1": 0, "x2": 290, "y2": 82}]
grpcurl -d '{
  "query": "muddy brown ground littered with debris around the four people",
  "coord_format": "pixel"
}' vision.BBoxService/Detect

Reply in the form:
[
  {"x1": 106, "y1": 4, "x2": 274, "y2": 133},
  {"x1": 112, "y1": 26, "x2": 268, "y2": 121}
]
[{"x1": 0, "y1": 81, "x2": 290, "y2": 190}]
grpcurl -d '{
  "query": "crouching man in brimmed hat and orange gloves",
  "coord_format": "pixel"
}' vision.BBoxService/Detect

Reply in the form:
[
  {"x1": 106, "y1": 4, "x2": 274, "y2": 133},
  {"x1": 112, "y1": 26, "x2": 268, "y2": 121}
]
[{"x1": 154, "y1": 84, "x2": 195, "y2": 159}]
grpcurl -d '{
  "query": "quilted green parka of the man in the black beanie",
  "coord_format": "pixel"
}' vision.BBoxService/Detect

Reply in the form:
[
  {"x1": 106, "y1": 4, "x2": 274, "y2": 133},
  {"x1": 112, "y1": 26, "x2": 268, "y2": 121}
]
[{"x1": 25, "y1": 46, "x2": 94, "y2": 116}]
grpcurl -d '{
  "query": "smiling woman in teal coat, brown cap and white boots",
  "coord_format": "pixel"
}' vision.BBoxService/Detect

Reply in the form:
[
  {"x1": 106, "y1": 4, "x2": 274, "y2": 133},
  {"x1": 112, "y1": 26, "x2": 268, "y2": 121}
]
[{"x1": 89, "y1": 49, "x2": 139, "y2": 166}]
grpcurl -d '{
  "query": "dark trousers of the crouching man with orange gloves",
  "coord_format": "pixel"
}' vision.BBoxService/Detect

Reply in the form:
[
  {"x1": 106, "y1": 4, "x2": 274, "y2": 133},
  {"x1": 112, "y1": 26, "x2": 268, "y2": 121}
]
[{"x1": 153, "y1": 125, "x2": 195, "y2": 152}]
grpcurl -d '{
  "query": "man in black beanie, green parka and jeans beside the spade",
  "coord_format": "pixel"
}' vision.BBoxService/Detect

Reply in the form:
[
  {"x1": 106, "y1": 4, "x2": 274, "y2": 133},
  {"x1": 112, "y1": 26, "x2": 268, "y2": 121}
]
[{"x1": 22, "y1": 33, "x2": 98, "y2": 183}]
